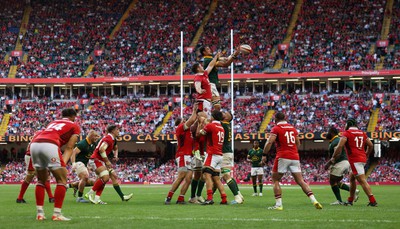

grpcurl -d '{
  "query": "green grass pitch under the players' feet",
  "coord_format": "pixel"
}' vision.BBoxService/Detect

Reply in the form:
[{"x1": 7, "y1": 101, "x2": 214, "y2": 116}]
[{"x1": 0, "y1": 185, "x2": 400, "y2": 229}]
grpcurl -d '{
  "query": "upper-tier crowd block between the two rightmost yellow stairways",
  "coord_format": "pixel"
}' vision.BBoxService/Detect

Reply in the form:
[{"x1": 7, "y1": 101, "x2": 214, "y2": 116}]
[{"x1": 283, "y1": 0, "x2": 385, "y2": 72}]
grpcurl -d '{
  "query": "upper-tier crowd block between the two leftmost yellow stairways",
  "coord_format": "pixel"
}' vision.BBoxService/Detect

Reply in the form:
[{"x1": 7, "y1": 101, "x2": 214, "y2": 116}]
[{"x1": 17, "y1": 0, "x2": 129, "y2": 78}]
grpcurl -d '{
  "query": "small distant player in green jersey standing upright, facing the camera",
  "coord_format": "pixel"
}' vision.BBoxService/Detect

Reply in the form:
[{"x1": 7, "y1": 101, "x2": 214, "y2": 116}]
[{"x1": 247, "y1": 140, "x2": 264, "y2": 196}]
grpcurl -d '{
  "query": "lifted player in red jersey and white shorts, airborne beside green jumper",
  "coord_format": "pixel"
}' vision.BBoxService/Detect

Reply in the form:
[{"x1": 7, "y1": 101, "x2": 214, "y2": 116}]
[{"x1": 192, "y1": 53, "x2": 221, "y2": 118}]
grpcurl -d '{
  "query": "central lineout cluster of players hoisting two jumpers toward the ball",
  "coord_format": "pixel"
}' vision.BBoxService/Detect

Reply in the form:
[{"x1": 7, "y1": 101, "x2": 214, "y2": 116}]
[{"x1": 165, "y1": 47, "x2": 244, "y2": 205}]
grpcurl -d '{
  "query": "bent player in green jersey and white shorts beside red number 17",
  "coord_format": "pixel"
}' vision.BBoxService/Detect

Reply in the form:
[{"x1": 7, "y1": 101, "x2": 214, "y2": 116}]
[{"x1": 325, "y1": 127, "x2": 360, "y2": 205}]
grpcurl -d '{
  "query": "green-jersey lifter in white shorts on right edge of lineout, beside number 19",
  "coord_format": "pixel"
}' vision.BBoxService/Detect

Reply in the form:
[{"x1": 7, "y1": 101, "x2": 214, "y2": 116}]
[{"x1": 221, "y1": 112, "x2": 244, "y2": 204}]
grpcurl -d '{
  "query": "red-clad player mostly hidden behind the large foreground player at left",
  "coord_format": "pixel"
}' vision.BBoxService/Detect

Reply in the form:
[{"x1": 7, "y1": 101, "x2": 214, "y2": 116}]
[{"x1": 16, "y1": 131, "x2": 54, "y2": 204}]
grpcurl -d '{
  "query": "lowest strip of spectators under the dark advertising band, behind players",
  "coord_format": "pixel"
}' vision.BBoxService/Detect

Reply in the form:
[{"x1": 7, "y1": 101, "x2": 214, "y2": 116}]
[{"x1": 0, "y1": 157, "x2": 400, "y2": 183}]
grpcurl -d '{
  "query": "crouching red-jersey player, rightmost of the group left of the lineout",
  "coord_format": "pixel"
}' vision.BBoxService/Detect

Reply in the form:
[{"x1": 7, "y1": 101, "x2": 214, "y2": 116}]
[{"x1": 85, "y1": 125, "x2": 119, "y2": 204}]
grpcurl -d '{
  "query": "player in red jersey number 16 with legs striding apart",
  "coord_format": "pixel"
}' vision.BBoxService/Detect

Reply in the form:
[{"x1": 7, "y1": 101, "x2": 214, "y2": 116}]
[{"x1": 263, "y1": 112, "x2": 322, "y2": 210}]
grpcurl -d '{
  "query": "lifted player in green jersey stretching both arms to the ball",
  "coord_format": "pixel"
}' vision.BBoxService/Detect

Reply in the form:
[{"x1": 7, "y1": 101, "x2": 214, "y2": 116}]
[{"x1": 199, "y1": 46, "x2": 240, "y2": 110}]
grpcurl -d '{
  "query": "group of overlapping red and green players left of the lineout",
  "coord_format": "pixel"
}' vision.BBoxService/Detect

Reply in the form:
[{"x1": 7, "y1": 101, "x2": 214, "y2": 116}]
[{"x1": 17, "y1": 108, "x2": 132, "y2": 221}]
